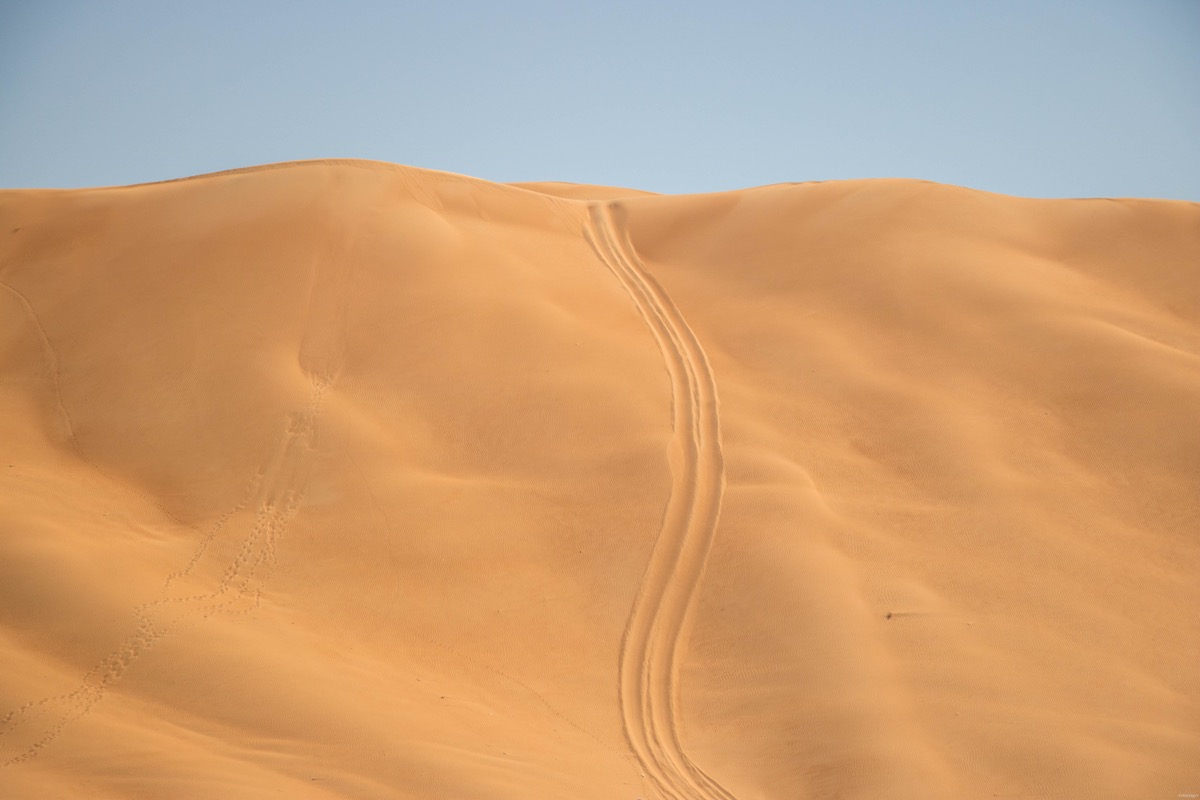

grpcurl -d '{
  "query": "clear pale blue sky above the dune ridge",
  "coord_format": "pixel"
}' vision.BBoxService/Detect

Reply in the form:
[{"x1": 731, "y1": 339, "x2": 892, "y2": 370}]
[{"x1": 0, "y1": 0, "x2": 1200, "y2": 200}]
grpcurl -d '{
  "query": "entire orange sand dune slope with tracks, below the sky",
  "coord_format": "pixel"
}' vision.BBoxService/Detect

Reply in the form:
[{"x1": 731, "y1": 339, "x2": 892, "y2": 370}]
[{"x1": 0, "y1": 162, "x2": 1200, "y2": 800}]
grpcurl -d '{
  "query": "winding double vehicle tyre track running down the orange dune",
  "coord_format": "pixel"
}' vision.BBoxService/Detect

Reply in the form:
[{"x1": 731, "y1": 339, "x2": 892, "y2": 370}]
[{"x1": 584, "y1": 203, "x2": 734, "y2": 800}]
